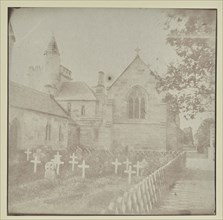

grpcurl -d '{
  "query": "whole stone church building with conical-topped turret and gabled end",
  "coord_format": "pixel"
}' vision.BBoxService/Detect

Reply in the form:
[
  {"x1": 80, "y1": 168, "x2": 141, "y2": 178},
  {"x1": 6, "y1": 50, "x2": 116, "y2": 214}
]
[{"x1": 9, "y1": 24, "x2": 180, "y2": 154}]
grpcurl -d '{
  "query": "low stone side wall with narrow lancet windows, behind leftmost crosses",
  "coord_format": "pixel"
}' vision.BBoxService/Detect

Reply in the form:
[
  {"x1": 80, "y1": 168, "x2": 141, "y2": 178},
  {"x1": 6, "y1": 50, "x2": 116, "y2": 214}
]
[{"x1": 9, "y1": 107, "x2": 68, "y2": 150}]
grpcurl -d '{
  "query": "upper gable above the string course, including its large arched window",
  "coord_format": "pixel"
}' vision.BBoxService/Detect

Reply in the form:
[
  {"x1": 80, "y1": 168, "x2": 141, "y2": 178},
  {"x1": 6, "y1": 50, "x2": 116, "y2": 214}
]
[{"x1": 108, "y1": 55, "x2": 166, "y2": 123}]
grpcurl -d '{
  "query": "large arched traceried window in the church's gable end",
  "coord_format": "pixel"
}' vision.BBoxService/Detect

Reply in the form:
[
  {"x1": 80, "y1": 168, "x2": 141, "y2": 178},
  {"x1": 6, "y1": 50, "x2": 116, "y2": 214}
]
[{"x1": 128, "y1": 86, "x2": 147, "y2": 119}]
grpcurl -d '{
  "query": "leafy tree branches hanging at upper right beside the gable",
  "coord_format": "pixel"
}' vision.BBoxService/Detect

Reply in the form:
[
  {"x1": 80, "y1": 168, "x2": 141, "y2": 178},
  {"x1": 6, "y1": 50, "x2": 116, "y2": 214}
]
[{"x1": 155, "y1": 10, "x2": 216, "y2": 119}]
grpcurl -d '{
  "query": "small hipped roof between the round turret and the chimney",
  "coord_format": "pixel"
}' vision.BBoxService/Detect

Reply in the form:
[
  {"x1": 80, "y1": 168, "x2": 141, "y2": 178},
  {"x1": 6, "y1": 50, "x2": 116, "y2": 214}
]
[{"x1": 56, "y1": 82, "x2": 96, "y2": 101}]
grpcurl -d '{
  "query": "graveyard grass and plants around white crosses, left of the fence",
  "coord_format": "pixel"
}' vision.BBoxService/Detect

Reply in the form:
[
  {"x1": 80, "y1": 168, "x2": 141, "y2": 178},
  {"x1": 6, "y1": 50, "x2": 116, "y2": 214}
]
[{"x1": 8, "y1": 150, "x2": 178, "y2": 214}]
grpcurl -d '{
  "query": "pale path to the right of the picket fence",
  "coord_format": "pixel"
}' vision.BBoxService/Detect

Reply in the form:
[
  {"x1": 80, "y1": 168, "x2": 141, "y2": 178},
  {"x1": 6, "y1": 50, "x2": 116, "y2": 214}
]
[{"x1": 153, "y1": 155, "x2": 215, "y2": 215}]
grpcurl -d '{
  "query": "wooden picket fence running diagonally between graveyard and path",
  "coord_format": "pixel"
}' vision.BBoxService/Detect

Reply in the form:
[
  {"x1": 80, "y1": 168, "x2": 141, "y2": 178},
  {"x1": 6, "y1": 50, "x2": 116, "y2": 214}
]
[{"x1": 103, "y1": 152, "x2": 186, "y2": 215}]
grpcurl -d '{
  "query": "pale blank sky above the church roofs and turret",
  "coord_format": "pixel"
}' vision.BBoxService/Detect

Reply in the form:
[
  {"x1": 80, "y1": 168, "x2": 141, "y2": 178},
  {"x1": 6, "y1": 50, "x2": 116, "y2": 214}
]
[{"x1": 10, "y1": 8, "x2": 215, "y2": 132}]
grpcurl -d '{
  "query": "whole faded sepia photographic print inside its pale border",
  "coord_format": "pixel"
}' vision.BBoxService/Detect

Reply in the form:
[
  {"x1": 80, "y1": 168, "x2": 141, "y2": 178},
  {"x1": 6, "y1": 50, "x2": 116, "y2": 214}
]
[{"x1": 2, "y1": 3, "x2": 220, "y2": 219}]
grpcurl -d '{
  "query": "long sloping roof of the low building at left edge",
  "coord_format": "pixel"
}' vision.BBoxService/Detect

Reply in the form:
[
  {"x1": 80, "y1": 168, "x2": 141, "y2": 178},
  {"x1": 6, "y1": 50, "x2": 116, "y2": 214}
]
[{"x1": 9, "y1": 82, "x2": 68, "y2": 118}]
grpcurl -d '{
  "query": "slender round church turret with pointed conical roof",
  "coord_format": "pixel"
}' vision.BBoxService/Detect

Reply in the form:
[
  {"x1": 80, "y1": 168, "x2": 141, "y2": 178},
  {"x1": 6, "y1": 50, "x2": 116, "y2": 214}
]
[{"x1": 44, "y1": 36, "x2": 60, "y2": 95}]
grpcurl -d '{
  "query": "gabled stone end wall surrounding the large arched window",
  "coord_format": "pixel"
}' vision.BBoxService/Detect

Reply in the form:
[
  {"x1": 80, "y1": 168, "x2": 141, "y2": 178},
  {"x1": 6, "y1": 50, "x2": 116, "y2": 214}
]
[{"x1": 108, "y1": 57, "x2": 167, "y2": 150}]
